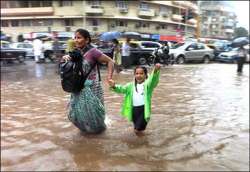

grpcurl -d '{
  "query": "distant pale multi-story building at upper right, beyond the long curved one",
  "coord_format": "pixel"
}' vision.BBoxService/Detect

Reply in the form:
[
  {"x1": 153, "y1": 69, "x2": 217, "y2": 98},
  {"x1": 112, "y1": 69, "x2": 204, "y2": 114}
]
[{"x1": 199, "y1": 1, "x2": 237, "y2": 39}]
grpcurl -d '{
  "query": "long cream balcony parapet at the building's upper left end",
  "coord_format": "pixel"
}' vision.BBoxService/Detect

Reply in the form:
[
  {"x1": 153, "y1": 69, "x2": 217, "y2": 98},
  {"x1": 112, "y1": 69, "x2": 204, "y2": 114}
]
[{"x1": 1, "y1": 7, "x2": 54, "y2": 17}]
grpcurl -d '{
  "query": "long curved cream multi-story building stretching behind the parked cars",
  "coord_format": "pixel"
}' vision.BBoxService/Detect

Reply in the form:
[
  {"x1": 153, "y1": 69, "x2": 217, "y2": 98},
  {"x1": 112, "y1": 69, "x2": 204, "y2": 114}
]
[{"x1": 1, "y1": 0, "x2": 198, "y2": 41}]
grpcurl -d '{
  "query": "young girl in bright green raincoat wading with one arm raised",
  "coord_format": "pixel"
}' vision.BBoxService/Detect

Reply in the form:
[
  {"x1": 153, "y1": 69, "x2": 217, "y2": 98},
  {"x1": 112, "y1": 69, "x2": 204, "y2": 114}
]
[{"x1": 109, "y1": 64, "x2": 160, "y2": 135}]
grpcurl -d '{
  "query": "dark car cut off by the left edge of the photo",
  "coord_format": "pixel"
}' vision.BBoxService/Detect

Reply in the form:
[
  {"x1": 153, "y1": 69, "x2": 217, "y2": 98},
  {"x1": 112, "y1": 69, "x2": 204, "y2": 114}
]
[{"x1": 0, "y1": 41, "x2": 26, "y2": 63}]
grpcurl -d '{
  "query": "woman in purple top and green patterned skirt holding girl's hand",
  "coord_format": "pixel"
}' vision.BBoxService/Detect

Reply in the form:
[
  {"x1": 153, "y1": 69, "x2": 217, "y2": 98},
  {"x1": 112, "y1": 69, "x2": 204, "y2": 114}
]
[{"x1": 62, "y1": 29, "x2": 114, "y2": 133}]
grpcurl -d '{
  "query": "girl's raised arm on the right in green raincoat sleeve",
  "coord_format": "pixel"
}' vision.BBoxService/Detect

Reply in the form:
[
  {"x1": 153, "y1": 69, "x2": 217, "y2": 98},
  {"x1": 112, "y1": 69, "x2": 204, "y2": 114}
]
[{"x1": 147, "y1": 63, "x2": 161, "y2": 89}]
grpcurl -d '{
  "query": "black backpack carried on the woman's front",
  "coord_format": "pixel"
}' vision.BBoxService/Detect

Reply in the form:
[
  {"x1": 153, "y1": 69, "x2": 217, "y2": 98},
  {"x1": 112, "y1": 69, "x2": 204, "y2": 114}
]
[{"x1": 60, "y1": 46, "x2": 96, "y2": 93}]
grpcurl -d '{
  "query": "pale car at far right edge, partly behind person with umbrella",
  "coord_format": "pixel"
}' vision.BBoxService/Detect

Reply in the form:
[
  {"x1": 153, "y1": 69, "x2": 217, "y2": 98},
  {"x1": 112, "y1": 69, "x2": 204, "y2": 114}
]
[{"x1": 216, "y1": 45, "x2": 249, "y2": 63}]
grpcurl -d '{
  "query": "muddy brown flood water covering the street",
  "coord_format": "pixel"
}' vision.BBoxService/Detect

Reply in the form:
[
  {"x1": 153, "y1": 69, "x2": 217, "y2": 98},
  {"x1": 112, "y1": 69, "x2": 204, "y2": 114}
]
[{"x1": 1, "y1": 61, "x2": 249, "y2": 171}]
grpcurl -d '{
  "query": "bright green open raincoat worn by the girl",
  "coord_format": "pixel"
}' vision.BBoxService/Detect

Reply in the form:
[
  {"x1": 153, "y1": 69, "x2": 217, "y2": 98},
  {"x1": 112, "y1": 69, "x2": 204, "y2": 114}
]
[{"x1": 111, "y1": 70, "x2": 160, "y2": 122}]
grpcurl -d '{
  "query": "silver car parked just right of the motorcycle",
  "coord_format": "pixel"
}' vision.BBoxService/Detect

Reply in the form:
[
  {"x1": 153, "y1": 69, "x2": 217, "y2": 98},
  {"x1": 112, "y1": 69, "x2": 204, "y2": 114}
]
[{"x1": 169, "y1": 42, "x2": 214, "y2": 64}]
